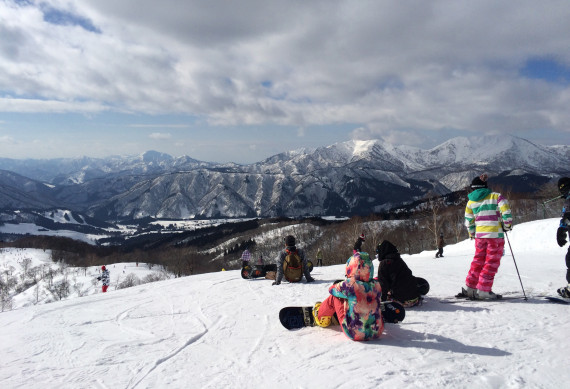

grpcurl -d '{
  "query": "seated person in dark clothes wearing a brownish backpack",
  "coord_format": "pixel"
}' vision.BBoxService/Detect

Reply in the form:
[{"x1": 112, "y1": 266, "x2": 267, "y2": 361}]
[{"x1": 272, "y1": 235, "x2": 315, "y2": 285}]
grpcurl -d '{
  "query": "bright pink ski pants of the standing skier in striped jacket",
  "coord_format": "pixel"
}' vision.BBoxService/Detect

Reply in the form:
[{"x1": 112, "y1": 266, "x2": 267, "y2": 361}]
[{"x1": 465, "y1": 238, "x2": 505, "y2": 292}]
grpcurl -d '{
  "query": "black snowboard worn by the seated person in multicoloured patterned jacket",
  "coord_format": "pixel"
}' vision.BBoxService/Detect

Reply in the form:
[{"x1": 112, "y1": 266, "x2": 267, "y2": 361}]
[{"x1": 279, "y1": 301, "x2": 406, "y2": 330}]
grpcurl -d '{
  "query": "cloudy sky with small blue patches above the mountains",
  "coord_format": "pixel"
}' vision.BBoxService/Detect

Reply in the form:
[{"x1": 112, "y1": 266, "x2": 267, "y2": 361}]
[{"x1": 0, "y1": 0, "x2": 570, "y2": 163}]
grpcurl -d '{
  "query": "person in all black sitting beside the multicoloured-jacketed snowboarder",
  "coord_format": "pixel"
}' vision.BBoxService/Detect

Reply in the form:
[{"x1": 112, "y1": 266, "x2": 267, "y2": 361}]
[{"x1": 376, "y1": 240, "x2": 429, "y2": 307}]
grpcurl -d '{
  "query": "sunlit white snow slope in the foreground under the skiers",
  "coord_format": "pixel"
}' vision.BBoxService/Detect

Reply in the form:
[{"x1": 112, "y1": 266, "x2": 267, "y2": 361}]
[{"x1": 0, "y1": 219, "x2": 570, "y2": 389}]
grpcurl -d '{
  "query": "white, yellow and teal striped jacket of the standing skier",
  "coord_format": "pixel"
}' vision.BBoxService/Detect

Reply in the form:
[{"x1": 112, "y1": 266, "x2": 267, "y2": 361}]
[{"x1": 465, "y1": 188, "x2": 513, "y2": 239}]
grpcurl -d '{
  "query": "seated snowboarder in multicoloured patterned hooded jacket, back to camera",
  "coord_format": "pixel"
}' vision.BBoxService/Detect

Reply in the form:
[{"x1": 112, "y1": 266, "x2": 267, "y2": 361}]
[{"x1": 313, "y1": 251, "x2": 384, "y2": 341}]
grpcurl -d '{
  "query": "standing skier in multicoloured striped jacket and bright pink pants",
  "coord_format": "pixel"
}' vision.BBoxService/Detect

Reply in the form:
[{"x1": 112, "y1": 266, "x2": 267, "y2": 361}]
[{"x1": 459, "y1": 174, "x2": 512, "y2": 299}]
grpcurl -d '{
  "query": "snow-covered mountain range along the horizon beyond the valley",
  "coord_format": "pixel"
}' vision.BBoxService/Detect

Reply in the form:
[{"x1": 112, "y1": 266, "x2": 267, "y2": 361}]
[{"x1": 0, "y1": 136, "x2": 570, "y2": 221}]
